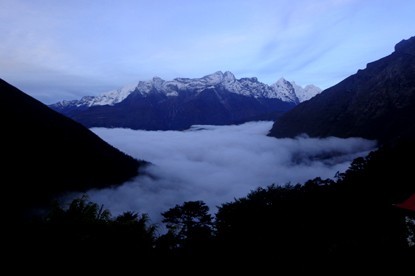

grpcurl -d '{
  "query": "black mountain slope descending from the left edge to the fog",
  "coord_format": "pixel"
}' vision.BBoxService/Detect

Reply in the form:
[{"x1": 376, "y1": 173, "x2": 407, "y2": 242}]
[{"x1": 0, "y1": 79, "x2": 144, "y2": 219}]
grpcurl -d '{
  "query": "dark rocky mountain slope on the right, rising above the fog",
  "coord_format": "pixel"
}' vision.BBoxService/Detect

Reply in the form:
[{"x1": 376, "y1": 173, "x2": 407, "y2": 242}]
[{"x1": 269, "y1": 37, "x2": 415, "y2": 143}]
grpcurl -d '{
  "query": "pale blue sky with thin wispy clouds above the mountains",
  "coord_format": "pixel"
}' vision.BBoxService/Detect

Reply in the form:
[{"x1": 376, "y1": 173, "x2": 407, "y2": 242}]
[{"x1": 0, "y1": 0, "x2": 415, "y2": 103}]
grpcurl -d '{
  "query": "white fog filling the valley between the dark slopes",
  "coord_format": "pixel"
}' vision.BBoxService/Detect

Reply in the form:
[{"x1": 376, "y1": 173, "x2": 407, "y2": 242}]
[{"x1": 87, "y1": 122, "x2": 376, "y2": 223}]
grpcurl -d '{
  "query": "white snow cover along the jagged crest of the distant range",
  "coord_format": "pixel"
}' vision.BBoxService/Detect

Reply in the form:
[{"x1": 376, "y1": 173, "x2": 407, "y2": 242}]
[{"x1": 49, "y1": 71, "x2": 321, "y2": 107}]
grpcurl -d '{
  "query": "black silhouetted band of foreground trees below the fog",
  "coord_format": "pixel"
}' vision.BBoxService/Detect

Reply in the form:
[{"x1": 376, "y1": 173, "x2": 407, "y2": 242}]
[{"x1": 19, "y1": 140, "x2": 415, "y2": 269}]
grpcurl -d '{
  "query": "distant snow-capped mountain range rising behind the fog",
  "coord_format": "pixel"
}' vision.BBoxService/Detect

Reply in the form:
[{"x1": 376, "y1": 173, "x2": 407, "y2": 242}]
[{"x1": 50, "y1": 71, "x2": 320, "y2": 129}]
